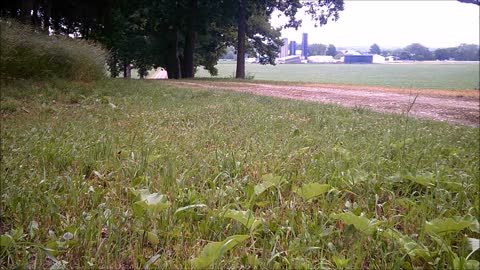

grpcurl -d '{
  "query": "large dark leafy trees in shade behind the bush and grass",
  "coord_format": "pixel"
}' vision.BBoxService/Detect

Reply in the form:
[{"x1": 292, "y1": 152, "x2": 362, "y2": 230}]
[{"x1": 0, "y1": 0, "x2": 344, "y2": 78}]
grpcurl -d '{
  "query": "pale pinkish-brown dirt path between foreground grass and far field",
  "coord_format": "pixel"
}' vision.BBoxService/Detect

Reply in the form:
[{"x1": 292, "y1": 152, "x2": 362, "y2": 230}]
[{"x1": 168, "y1": 81, "x2": 480, "y2": 127}]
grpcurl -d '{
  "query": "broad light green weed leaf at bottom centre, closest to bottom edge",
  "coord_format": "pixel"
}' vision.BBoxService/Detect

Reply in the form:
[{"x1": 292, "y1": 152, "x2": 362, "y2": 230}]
[{"x1": 191, "y1": 235, "x2": 249, "y2": 268}]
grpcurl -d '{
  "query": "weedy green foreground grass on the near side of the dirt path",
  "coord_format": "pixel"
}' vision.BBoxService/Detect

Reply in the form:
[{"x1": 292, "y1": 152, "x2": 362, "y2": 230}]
[{"x1": 0, "y1": 79, "x2": 480, "y2": 269}]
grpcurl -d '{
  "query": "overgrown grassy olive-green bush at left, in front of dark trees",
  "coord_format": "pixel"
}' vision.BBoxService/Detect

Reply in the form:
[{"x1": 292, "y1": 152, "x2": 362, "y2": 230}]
[{"x1": 0, "y1": 19, "x2": 106, "y2": 81}]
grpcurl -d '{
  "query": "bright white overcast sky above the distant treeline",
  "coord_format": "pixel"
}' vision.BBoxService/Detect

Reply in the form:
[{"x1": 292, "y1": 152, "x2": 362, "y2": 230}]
[{"x1": 272, "y1": 0, "x2": 480, "y2": 48}]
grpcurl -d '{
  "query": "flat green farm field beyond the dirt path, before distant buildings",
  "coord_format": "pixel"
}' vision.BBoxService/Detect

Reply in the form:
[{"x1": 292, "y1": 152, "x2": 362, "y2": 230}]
[{"x1": 196, "y1": 62, "x2": 480, "y2": 90}]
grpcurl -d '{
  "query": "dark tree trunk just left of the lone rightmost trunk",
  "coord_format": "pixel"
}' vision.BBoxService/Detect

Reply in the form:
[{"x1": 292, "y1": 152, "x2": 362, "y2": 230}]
[{"x1": 182, "y1": 0, "x2": 198, "y2": 78}]
